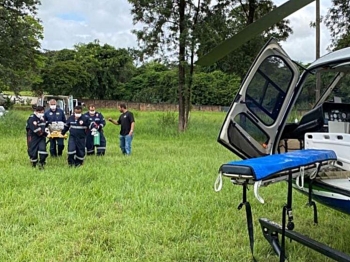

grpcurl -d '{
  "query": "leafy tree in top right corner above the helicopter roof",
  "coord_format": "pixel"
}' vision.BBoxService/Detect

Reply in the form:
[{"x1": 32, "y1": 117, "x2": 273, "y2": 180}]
[{"x1": 325, "y1": 0, "x2": 350, "y2": 50}]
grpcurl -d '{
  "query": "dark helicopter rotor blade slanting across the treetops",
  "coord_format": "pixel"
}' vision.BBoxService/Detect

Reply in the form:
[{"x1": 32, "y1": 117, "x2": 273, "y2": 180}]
[{"x1": 196, "y1": 0, "x2": 315, "y2": 66}]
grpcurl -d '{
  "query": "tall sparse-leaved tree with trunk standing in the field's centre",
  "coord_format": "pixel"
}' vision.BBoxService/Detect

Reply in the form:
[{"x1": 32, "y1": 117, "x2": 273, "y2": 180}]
[{"x1": 128, "y1": 0, "x2": 210, "y2": 131}]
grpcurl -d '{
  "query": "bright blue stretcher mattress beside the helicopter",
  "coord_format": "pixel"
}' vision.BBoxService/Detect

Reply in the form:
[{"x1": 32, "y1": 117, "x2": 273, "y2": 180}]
[{"x1": 220, "y1": 149, "x2": 337, "y2": 180}]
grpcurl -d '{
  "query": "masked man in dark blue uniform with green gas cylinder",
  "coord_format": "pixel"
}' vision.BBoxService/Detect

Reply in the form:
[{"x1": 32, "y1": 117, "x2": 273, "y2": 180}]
[{"x1": 85, "y1": 105, "x2": 107, "y2": 156}]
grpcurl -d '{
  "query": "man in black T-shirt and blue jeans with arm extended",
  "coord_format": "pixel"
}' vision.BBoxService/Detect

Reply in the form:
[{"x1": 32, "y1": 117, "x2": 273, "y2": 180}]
[{"x1": 108, "y1": 103, "x2": 135, "y2": 155}]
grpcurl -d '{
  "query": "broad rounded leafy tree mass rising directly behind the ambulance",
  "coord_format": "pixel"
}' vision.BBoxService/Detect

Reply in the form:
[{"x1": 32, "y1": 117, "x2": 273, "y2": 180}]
[{"x1": 37, "y1": 40, "x2": 135, "y2": 99}]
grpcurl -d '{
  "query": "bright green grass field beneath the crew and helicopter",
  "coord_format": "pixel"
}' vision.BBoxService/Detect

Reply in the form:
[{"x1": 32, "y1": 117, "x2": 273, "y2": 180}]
[{"x1": 0, "y1": 110, "x2": 350, "y2": 261}]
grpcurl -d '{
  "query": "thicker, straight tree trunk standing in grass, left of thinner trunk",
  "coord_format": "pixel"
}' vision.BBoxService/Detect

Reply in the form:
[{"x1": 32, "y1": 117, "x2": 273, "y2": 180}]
[{"x1": 178, "y1": 0, "x2": 187, "y2": 132}]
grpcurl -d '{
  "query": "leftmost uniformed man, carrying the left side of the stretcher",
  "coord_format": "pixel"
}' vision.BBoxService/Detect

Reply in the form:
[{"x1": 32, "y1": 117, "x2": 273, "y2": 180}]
[{"x1": 26, "y1": 106, "x2": 48, "y2": 169}]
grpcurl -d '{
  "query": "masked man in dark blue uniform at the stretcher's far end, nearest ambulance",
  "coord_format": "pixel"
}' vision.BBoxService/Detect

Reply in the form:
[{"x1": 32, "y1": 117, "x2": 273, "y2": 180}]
[{"x1": 44, "y1": 99, "x2": 66, "y2": 157}]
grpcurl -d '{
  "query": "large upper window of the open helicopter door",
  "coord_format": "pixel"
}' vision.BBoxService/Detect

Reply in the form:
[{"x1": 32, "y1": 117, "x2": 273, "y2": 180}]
[{"x1": 246, "y1": 56, "x2": 293, "y2": 126}]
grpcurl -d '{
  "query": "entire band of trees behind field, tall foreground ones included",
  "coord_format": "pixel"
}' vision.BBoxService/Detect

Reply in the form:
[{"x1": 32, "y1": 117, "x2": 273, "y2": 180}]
[{"x1": 0, "y1": 0, "x2": 350, "y2": 131}]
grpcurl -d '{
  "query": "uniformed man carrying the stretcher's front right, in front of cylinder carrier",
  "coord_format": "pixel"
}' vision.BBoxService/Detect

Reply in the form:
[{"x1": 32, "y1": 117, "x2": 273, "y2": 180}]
[{"x1": 61, "y1": 106, "x2": 93, "y2": 167}]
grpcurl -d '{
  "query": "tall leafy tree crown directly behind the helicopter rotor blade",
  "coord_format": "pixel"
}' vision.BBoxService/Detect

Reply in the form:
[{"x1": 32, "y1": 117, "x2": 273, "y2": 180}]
[{"x1": 197, "y1": 0, "x2": 292, "y2": 79}]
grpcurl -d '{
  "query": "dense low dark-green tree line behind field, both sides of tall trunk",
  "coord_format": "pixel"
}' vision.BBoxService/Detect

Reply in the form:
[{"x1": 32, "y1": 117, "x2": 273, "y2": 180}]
[{"x1": 32, "y1": 40, "x2": 239, "y2": 105}]
